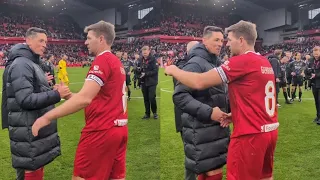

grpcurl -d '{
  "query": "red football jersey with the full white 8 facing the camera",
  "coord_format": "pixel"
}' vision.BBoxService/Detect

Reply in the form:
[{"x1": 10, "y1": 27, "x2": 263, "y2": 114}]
[{"x1": 217, "y1": 52, "x2": 279, "y2": 137}]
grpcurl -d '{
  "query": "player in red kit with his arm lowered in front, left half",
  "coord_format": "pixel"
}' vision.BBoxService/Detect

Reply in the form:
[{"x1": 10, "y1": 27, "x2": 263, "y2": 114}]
[{"x1": 32, "y1": 21, "x2": 128, "y2": 180}]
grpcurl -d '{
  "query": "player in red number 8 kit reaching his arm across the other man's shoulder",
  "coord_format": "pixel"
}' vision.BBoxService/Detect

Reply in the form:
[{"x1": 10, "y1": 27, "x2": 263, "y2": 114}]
[{"x1": 166, "y1": 21, "x2": 279, "y2": 180}]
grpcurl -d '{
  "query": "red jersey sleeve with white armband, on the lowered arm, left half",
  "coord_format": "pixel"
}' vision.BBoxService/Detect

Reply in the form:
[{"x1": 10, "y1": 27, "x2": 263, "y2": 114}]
[{"x1": 86, "y1": 56, "x2": 110, "y2": 86}]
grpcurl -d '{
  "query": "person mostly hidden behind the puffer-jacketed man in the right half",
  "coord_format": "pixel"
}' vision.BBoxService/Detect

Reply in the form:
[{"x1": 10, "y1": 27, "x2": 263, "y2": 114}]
[{"x1": 172, "y1": 41, "x2": 199, "y2": 180}]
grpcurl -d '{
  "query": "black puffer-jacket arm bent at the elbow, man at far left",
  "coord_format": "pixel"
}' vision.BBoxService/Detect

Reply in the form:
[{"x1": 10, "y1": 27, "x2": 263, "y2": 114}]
[{"x1": 9, "y1": 59, "x2": 61, "y2": 110}]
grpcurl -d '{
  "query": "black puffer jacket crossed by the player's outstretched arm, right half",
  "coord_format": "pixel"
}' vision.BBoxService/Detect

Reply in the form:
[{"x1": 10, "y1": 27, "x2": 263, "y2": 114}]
[{"x1": 173, "y1": 44, "x2": 230, "y2": 174}]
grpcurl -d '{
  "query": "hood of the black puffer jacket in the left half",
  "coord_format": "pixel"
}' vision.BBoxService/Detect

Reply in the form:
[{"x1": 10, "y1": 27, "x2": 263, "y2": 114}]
[{"x1": 6, "y1": 43, "x2": 40, "y2": 65}]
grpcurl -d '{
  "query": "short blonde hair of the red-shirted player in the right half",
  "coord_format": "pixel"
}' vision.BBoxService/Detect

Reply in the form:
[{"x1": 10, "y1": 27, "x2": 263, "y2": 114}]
[{"x1": 225, "y1": 20, "x2": 258, "y2": 45}]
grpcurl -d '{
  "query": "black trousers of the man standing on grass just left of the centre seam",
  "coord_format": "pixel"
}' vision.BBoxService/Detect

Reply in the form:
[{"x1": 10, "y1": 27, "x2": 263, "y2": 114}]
[{"x1": 141, "y1": 83, "x2": 157, "y2": 116}]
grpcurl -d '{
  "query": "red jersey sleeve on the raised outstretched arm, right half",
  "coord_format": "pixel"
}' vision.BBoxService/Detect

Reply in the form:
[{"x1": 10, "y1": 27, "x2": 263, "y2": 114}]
[{"x1": 216, "y1": 57, "x2": 249, "y2": 83}]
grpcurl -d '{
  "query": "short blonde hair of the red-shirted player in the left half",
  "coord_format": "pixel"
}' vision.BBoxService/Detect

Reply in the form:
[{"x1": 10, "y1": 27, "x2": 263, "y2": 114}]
[{"x1": 84, "y1": 21, "x2": 116, "y2": 46}]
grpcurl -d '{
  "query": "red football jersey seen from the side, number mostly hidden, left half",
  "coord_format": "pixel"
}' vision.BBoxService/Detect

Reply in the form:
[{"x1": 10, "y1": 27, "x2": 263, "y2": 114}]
[{"x1": 83, "y1": 51, "x2": 128, "y2": 132}]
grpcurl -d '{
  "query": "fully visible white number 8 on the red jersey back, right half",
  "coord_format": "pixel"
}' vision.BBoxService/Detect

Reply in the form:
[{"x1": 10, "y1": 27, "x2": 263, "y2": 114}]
[{"x1": 264, "y1": 81, "x2": 276, "y2": 117}]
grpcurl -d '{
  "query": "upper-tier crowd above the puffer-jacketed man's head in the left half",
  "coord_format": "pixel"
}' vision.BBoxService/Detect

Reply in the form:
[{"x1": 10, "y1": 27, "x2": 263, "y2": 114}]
[{"x1": 0, "y1": 13, "x2": 85, "y2": 39}]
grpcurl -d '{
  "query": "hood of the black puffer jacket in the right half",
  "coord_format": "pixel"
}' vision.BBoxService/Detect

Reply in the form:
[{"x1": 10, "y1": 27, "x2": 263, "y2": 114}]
[{"x1": 188, "y1": 43, "x2": 220, "y2": 66}]
